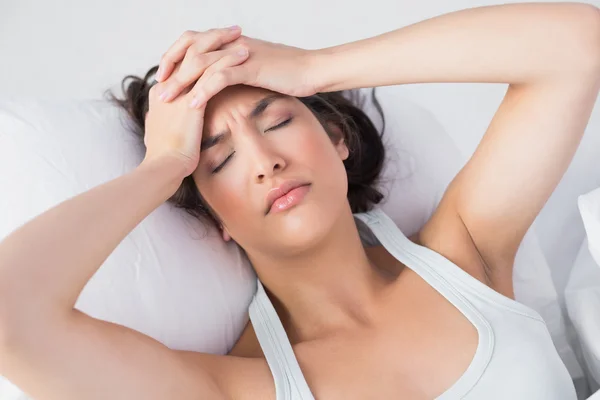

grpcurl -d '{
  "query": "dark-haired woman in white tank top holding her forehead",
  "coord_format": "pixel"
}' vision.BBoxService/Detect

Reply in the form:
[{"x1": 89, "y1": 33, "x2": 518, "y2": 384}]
[{"x1": 0, "y1": 3, "x2": 600, "y2": 400}]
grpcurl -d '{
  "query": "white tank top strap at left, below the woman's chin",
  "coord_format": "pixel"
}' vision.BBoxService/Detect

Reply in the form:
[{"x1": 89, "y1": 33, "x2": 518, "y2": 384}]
[{"x1": 249, "y1": 279, "x2": 314, "y2": 400}]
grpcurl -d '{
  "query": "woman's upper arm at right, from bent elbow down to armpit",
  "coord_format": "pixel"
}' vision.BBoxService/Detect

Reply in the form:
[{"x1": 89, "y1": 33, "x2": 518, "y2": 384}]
[{"x1": 442, "y1": 24, "x2": 600, "y2": 285}]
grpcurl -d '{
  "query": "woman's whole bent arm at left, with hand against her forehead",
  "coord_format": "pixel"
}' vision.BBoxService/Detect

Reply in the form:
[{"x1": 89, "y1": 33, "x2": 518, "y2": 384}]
[{"x1": 0, "y1": 67, "x2": 234, "y2": 400}]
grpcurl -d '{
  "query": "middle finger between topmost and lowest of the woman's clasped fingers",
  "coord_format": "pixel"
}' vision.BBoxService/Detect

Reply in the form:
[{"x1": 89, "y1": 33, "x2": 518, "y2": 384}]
[{"x1": 158, "y1": 47, "x2": 248, "y2": 101}]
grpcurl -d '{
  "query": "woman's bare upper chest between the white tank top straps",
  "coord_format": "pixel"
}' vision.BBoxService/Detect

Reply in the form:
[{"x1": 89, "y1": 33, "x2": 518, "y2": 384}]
[{"x1": 294, "y1": 271, "x2": 478, "y2": 400}]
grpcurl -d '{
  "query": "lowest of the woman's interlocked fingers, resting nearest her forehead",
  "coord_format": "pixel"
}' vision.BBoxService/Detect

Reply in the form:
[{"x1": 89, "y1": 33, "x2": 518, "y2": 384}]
[{"x1": 189, "y1": 51, "x2": 248, "y2": 108}]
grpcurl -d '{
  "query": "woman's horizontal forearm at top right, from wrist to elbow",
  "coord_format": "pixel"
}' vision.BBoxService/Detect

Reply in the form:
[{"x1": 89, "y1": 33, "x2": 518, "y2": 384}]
[{"x1": 313, "y1": 3, "x2": 600, "y2": 91}]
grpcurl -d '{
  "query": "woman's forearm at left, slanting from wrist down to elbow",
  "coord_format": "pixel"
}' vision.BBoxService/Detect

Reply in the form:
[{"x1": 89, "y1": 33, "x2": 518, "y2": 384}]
[{"x1": 0, "y1": 159, "x2": 181, "y2": 323}]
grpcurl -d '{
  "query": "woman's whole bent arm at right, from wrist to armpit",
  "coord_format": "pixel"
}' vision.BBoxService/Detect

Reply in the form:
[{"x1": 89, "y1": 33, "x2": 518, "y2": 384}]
[{"x1": 313, "y1": 3, "x2": 600, "y2": 297}]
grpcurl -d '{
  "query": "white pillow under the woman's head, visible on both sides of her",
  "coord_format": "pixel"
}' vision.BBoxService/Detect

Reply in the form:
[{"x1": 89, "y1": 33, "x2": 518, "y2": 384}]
[{"x1": 0, "y1": 87, "x2": 576, "y2": 400}]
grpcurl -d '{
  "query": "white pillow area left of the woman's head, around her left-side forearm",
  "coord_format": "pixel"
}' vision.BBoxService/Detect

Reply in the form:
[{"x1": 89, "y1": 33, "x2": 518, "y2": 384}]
[{"x1": 0, "y1": 97, "x2": 254, "y2": 353}]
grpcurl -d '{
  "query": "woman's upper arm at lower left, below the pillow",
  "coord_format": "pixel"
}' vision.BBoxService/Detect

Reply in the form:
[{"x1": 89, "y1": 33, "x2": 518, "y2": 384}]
[{"x1": 0, "y1": 310, "x2": 224, "y2": 400}]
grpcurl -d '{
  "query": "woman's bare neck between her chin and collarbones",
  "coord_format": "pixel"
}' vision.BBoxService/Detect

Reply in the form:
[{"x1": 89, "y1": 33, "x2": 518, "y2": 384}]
[{"x1": 248, "y1": 207, "x2": 386, "y2": 343}]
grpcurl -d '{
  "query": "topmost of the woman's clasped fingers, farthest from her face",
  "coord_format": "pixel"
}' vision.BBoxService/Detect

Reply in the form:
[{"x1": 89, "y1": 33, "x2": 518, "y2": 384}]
[{"x1": 155, "y1": 25, "x2": 242, "y2": 82}]
